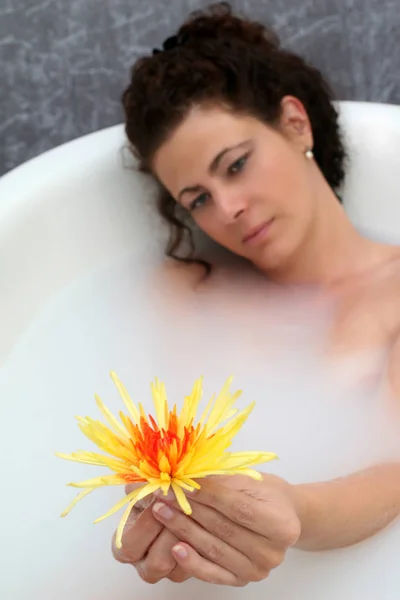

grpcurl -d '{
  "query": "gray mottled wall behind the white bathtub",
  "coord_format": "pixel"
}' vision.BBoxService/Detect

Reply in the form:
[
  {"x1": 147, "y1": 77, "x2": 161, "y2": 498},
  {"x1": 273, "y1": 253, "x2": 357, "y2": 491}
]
[{"x1": 0, "y1": 0, "x2": 400, "y2": 174}]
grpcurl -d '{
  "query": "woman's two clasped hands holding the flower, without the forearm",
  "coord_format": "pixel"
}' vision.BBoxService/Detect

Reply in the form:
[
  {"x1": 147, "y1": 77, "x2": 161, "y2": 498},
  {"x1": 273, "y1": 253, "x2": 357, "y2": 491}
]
[{"x1": 113, "y1": 475, "x2": 300, "y2": 586}]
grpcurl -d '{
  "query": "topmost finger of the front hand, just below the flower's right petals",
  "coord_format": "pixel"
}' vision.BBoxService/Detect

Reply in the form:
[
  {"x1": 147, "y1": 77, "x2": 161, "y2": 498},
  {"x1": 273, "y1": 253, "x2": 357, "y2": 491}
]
[{"x1": 190, "y1": 481, "x2": 298, "y2": 547}]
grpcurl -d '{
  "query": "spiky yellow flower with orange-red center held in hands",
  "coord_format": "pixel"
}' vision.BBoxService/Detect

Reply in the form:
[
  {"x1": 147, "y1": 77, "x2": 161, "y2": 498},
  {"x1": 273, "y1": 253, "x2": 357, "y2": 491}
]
[{"x1": 57, "y1": 373, "x2": 277, "y2": 547}]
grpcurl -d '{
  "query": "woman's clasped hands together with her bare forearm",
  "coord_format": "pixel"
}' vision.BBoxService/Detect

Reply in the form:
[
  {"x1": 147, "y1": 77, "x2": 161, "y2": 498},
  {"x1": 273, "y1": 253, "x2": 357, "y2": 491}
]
[{"x1": 115, "y1": 461, "x2": 400, "y2": 586}]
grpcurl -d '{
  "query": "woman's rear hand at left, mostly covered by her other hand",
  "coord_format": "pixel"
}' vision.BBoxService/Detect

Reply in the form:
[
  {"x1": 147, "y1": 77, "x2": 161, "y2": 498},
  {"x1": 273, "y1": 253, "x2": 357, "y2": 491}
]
[{"x1": 112, "y1": 486, "x2": 190, "y2": 583}]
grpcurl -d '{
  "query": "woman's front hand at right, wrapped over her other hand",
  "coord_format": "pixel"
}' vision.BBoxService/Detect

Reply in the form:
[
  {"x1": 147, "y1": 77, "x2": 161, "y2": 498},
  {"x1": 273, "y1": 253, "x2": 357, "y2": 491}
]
[{"x1": 152, "y1": 475, "x2": 300, "y2": 586}]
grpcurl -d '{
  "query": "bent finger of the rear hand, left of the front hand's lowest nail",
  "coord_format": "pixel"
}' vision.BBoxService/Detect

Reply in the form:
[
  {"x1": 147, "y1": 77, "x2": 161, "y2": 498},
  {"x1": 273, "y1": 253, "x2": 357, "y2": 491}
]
[{"x1": 140, "y1": 529, "x2": 179, "y2": 583}]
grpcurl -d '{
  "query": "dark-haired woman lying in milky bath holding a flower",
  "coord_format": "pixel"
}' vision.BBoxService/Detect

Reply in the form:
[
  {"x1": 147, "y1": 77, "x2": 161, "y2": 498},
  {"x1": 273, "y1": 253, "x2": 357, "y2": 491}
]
[{"x1": 114, "y1": 4, "x2": 400, "y2": 586}]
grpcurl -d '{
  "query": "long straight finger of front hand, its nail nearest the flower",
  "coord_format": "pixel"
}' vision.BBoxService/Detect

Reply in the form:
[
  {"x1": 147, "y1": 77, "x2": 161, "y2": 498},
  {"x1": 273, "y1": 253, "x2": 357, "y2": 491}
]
[{"x1": 153, "y1": 502, "x2": 253, "y2": 580}]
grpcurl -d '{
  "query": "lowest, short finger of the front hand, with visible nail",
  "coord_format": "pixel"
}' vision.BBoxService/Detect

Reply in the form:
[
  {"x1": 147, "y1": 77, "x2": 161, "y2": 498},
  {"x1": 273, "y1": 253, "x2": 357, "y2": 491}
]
[{"x1": 172, "y1": 542, "x2": 244, "y2": 587}]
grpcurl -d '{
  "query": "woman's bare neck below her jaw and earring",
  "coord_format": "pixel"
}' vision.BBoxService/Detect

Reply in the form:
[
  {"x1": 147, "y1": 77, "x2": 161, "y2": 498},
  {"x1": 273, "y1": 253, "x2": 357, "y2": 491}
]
[{"x1": 260, "y1": 176, "x2": 398, "y2": 288}]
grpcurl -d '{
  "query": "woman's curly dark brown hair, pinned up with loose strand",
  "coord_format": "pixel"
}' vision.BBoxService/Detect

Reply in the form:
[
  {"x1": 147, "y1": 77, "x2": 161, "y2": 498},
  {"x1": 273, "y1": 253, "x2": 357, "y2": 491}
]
[{"x1": 122, "y1": 2, "x2": 346, "y2": 271}]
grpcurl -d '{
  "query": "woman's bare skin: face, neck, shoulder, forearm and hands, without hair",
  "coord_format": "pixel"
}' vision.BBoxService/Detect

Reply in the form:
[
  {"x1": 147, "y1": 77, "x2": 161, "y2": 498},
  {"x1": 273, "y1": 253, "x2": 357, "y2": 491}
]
[{"x1": 113, "y1": 96, "x2": 400, "y2": 586}]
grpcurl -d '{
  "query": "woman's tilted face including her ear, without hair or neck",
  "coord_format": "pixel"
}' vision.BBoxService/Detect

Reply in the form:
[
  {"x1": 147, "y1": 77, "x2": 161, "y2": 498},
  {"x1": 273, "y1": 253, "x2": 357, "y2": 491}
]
[{"x1": 153, "y1": 97, "x2": 318, "y2": 270}]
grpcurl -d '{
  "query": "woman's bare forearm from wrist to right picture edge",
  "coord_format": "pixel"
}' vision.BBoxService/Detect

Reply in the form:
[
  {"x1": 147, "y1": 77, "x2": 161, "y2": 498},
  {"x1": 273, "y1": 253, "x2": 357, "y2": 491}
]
[{"x1": 293, "y1": 462, "x2": 400, "y2": 550}]
